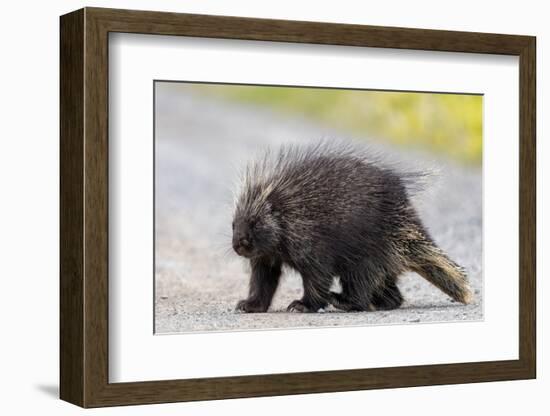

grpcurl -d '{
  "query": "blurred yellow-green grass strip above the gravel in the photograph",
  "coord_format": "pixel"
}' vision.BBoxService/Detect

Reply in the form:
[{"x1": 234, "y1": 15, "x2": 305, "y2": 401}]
[{"x1": 196, "y1": 84, "x2": 483, "y2": 165}]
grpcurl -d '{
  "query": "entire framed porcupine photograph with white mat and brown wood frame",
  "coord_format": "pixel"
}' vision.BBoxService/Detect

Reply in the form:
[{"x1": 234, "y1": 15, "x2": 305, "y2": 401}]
[{"x1": 60, "y1": 8, "x2": 536, "y2": 407}]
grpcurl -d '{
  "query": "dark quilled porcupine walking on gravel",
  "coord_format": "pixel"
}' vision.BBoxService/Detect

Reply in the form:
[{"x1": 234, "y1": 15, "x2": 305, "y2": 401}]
[{"x1": 232, "y1": 142, "x2": 472, "y2": 312}]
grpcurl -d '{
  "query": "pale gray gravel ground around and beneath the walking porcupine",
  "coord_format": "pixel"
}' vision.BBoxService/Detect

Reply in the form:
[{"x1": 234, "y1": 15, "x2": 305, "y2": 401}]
[{"x1": 155, "y1": 83, "x2": 483, "y2": 333}]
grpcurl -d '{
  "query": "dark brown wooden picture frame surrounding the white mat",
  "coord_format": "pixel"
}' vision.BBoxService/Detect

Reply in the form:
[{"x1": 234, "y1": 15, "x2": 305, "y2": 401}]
[{"x1": 60, "y1": 8, "x2": 536, "y2": 407}]
